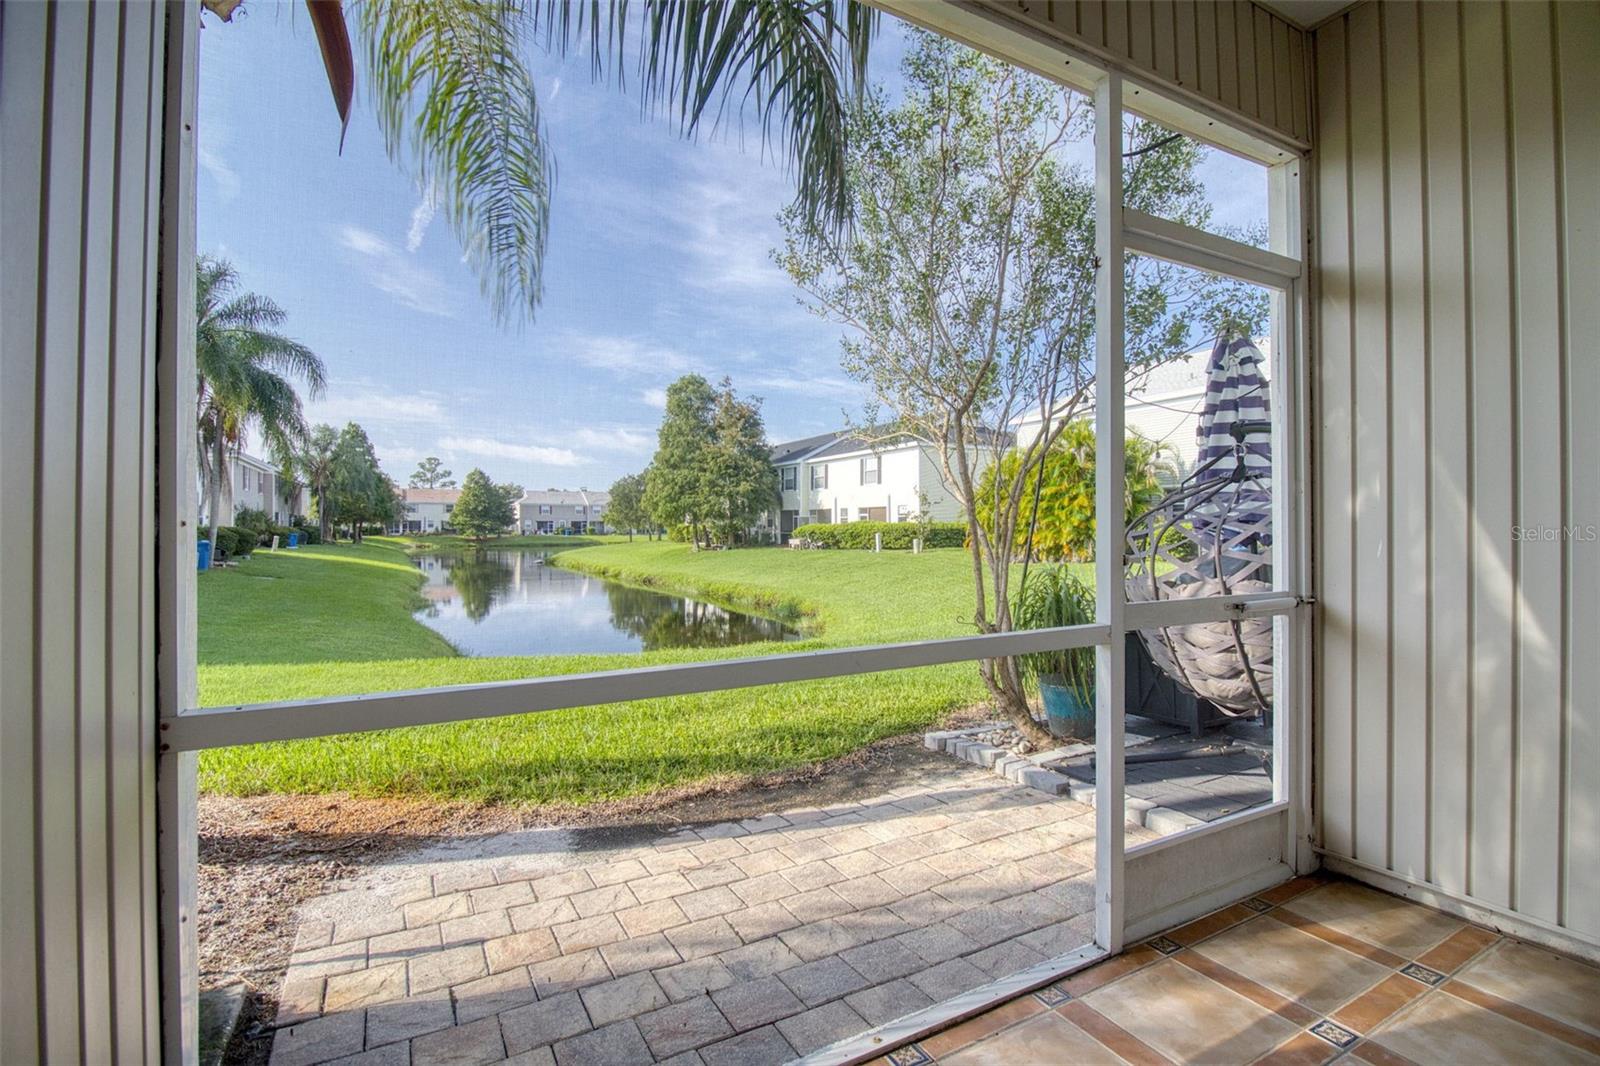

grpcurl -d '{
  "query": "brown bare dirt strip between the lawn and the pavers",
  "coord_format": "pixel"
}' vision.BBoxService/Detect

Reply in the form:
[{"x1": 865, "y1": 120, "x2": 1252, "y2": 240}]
[{"x1": 197, "y1": 726, "x2": 984, "y2": 1063}]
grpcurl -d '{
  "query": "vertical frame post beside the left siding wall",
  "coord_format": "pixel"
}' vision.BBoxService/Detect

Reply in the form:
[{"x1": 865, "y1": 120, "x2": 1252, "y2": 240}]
[{"x1": 156, "y1": 0, "x2": 200, "y2": 1066}]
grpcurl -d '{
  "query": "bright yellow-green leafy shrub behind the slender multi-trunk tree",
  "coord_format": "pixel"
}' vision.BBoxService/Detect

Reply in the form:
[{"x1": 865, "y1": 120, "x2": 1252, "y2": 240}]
[{"x1": 978, "y1": 418, "x2": 1178, "y2": 562}]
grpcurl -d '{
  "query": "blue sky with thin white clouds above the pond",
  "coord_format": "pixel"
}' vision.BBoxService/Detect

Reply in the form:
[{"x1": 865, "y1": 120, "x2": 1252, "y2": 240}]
[{"x1": 198, "y1": 2, "x2": 1266, "y2": 488}]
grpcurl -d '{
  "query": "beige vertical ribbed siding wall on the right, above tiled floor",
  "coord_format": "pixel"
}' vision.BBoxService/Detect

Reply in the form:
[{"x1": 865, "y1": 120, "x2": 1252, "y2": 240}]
[{"x1": 1314, "y1": 0, "x2": 1600, "y2": 941}]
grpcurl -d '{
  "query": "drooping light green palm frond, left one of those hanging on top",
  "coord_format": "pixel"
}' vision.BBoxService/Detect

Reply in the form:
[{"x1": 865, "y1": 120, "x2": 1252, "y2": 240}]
[{"x1": 355, "y1": 0, "x2": 555, "y2": 323}]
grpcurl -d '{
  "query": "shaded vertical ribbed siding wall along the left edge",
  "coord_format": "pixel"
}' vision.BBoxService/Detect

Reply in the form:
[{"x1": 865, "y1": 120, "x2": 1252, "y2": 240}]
[{"x1": 0, "y1": 3, "x2": 165, "y2": 1063}]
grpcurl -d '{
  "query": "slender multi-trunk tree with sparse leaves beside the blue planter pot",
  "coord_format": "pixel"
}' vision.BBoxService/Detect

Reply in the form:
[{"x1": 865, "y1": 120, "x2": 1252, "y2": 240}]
[{"x1": 776, "y1": 32, "x2": 1264, "y2": 744}]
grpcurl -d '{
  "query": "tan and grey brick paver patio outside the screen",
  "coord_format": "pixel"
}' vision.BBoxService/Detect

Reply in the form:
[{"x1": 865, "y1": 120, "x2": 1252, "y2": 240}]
[{"x1": 272, "y1": 763, "x2": 1113, "y2": 1066}]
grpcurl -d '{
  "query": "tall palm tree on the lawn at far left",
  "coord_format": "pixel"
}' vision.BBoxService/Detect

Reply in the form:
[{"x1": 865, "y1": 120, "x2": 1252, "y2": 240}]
[{"x1": 195, "y1": 256, "x2": 326, "y2": 560}]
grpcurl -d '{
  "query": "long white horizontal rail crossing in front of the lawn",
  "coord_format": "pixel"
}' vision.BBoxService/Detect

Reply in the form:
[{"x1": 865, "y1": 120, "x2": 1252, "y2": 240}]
[{"x1": 162, "y1": 624, "x2": 1110, "y2": 752}]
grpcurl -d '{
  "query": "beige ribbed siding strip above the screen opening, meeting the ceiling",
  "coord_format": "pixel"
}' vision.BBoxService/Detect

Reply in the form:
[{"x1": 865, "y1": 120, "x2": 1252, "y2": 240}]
[{"x1": 992, "y1": 0, "x2": 1310, "y2": 144}]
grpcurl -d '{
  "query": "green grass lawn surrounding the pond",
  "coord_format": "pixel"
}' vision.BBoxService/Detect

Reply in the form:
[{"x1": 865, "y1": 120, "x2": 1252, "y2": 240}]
[{"x1": 200, "y1": 538, "x2": 1024, "y2": 804}]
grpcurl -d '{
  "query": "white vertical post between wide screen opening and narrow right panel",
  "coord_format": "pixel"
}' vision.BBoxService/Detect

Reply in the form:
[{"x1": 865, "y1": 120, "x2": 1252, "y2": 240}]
[{"x1": 1094, "y1": 70, "x2": 1126, "y2": 952}]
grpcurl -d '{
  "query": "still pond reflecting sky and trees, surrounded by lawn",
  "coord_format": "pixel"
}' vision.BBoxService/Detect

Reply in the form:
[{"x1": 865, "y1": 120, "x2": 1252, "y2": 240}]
[{"x1": 413, "y1": 549, "x2": 798, "y2": 656}]
